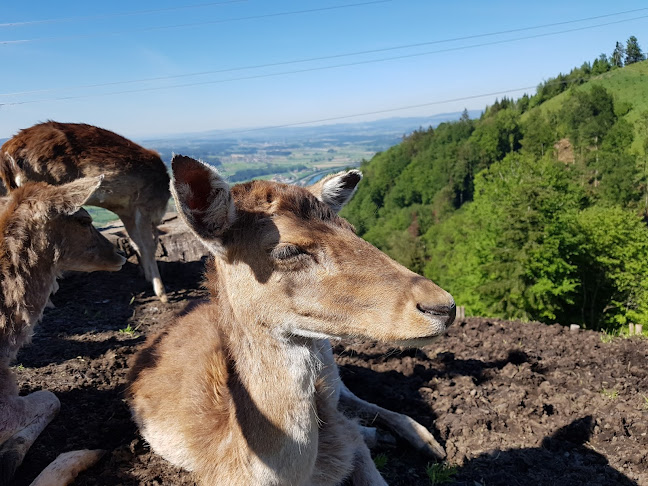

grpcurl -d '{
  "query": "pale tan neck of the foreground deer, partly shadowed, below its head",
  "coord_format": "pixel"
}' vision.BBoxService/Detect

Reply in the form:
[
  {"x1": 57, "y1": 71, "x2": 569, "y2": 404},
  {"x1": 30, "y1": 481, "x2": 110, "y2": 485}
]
[{"x1": 220, "y1": 294, "x2": 321, "y2": 470}]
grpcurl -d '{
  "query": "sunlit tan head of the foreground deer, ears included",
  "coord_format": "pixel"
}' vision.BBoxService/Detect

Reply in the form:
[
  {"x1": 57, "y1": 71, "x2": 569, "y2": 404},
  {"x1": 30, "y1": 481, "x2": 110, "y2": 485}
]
[{"x1": 172, "y1": 155, "x2": 455, "y2": 345}]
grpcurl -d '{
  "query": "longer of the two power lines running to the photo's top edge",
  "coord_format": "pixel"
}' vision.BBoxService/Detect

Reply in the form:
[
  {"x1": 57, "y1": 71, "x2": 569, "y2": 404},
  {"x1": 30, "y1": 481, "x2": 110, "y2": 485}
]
[{"x1": 0, "y1": 0, "x2": 394, "y2": 45}]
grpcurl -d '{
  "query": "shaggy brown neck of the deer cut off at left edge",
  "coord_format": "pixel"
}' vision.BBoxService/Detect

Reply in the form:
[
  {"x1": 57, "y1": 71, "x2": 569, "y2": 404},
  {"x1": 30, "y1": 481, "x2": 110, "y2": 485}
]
[{"x1": 0, "y1": 236, "x2": 59, "y2": 360}]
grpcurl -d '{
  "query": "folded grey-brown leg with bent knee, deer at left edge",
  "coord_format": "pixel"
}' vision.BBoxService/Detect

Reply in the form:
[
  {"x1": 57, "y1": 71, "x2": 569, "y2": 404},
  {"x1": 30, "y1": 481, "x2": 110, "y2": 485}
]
[{"x1": 0, "y1": 390, "x2": 61, "y2": 486}]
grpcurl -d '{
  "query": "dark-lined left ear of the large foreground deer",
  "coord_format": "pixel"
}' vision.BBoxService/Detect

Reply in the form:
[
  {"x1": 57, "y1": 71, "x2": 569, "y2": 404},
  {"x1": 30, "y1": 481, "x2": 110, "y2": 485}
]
[{"x1": 171, "y1": 155, "x2": 236, "y2": 248}]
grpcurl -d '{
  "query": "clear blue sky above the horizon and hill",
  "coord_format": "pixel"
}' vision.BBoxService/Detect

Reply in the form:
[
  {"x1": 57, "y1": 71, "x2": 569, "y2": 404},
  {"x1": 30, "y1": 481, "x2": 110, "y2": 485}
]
[{"x1": 0, "y1": 0, "x2": 648, "y2": 138}]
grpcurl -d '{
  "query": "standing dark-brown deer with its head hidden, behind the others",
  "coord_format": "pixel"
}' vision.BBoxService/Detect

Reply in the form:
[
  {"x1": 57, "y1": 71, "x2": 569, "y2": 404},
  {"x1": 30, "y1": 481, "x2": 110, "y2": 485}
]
[{"x1": 0, "y1": 121, "x2": 170, "y2": 302}]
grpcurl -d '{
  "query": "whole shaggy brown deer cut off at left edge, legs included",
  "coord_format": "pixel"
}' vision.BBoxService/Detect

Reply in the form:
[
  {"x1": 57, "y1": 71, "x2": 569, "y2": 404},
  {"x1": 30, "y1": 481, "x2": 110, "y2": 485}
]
[{"x1": 0, "y1": 177, "x2": 126, "y2": 486}]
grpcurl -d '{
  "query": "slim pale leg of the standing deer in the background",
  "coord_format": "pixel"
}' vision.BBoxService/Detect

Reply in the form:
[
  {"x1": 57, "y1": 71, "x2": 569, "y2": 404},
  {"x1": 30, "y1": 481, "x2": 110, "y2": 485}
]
[{"x1": 120, "y1": 209, "x2": 168, "y2": 302}]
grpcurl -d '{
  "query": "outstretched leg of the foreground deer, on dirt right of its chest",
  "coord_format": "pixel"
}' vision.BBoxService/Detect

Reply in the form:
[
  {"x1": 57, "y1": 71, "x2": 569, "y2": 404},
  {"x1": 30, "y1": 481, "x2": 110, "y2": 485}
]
[{"x1": 340, "y1": 383, "x2": 446, "y2": 460}]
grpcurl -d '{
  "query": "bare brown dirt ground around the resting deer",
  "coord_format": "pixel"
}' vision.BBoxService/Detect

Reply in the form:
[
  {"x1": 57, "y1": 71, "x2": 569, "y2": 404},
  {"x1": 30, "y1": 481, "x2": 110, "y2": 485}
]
[{"x1": 14, "y1": 262, "x2": 648, "y2": 486}]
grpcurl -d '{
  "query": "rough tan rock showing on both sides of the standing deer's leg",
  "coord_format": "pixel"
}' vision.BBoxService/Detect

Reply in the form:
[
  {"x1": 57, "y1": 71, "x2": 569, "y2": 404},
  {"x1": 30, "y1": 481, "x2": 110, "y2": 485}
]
[{"x1": 99, "y1": 212, "x2": 209, "y2": 262}]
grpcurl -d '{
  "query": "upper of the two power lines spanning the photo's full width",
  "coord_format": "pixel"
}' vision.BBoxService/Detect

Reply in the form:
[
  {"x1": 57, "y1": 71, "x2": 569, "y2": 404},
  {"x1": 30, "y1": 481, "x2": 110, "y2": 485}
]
[{"x1": 0, "y1": 7, "x2": 648, "y2": 96}]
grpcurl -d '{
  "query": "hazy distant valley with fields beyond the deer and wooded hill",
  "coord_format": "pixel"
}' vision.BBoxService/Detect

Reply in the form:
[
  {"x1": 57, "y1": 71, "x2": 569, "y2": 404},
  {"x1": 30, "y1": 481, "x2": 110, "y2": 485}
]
[{"x1": 138, "y1": 111, "x2": 479, "y2": 184}]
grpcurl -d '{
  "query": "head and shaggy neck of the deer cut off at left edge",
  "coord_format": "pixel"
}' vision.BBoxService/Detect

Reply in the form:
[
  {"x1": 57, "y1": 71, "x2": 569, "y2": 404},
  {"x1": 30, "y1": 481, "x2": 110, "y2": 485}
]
[{"x1": 0, "y1": 180, "x2": 124, "y2": 358}]
